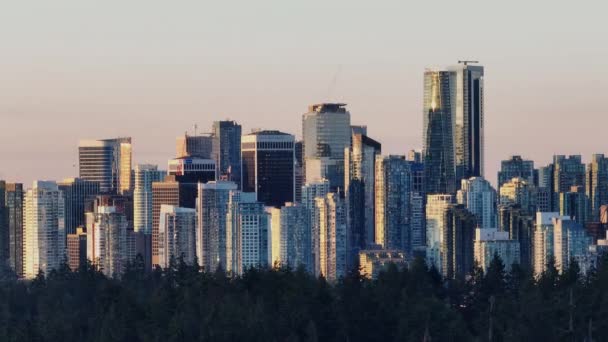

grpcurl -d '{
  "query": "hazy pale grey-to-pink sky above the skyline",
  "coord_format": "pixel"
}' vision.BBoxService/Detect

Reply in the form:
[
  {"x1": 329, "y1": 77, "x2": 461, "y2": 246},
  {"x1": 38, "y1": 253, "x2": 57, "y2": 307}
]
[{"x1": 0, "y1": 0, "x2": 608, "y2": 183}]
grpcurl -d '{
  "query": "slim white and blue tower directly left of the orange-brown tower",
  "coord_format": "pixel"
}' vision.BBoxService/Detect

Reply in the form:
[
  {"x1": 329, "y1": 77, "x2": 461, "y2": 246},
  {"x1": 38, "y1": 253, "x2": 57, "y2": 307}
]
[{"x1": 133, "y1": 164, "x2": 167, "y2": 234}]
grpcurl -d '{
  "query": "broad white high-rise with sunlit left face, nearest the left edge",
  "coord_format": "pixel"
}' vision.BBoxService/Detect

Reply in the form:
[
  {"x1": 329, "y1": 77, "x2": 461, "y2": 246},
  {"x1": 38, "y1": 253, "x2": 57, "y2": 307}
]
[{"x1": 23, "y1": 181, "x2": 66, "y2": 279}]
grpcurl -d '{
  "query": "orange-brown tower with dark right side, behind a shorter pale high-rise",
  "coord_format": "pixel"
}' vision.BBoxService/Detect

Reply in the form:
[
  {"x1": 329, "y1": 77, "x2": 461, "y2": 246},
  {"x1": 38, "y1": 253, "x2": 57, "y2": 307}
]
[{"x1": 151, "y1": 176, "x2": 197, "y2": 265}]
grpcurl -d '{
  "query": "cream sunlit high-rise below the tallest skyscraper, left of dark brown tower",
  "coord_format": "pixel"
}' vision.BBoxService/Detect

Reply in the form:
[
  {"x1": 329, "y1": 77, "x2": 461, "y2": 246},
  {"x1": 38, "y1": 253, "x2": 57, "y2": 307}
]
[{"x1": 426, "y1": 194, "x2": 453, "y2": 272}]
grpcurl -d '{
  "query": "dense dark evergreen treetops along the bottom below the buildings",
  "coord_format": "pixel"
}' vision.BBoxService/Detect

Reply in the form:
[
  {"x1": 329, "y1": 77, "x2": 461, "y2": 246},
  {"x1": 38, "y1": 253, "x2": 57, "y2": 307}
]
[{"x1": 0, "y1": 255, "x2": 608, "y2": 342}]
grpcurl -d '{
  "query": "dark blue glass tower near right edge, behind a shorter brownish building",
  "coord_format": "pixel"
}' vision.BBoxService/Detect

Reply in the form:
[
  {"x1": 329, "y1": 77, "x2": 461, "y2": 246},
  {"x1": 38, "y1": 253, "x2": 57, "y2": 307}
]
[{"x1": 553, "y1": 155, "x2": 585, "y2": 211}]
